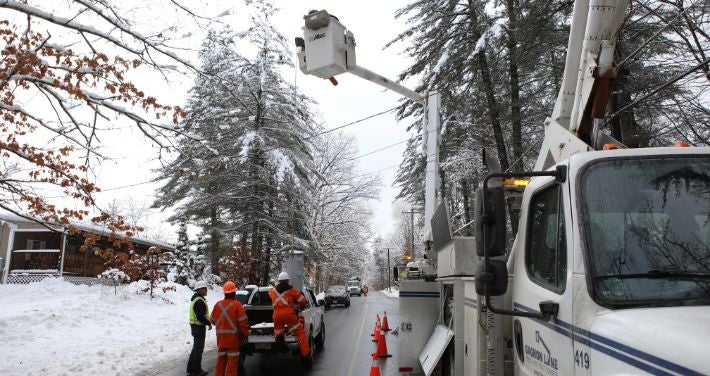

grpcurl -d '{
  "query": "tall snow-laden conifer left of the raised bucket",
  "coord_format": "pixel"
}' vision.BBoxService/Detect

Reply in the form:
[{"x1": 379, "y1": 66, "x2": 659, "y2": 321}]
[{"x1": 154, "y1": 1, "x2": 315, "y2": 283}]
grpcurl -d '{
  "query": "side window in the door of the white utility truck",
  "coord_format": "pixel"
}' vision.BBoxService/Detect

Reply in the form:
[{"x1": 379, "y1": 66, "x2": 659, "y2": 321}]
[{"x1": 525, "y1": 184, "x2": 567, "y2": 293}]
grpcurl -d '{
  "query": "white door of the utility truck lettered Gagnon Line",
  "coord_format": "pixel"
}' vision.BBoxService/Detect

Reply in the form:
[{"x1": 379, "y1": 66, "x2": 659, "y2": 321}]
[{"x1": 513, "y1": 178, "x2": 574, "y2": 376}]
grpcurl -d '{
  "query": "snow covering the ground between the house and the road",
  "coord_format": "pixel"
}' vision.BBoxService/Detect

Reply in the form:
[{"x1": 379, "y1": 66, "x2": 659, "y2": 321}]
[{"x1": 0, "y1": 278, "x2": 222, "y2": 376}]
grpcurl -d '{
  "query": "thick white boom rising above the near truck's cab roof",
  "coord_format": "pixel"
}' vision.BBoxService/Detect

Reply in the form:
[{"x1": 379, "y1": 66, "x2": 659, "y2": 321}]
[{"x1": 535, "y1": 0, "x2": 627, "y2": 171}]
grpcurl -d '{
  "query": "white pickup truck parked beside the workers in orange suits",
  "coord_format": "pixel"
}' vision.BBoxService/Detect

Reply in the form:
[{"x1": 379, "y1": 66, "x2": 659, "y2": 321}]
[{"x1": 238, "y1": 287, "x2": 325, "y2": 369}]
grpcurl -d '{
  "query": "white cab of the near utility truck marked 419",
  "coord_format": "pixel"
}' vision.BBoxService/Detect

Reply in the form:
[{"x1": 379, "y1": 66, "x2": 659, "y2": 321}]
[{"x1": 506, "y1": 147, "x2": 710, "y2": 375}]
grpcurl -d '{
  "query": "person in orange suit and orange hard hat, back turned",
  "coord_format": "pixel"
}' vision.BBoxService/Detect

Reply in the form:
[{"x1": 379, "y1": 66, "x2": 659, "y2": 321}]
[{"x1": 212, "y1": 281, "x2": 249, "y2": 376}]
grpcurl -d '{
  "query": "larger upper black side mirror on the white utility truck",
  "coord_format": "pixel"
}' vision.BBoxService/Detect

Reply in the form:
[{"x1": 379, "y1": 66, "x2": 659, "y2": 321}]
[{"x1": 473, "y1": 187, "x2": 505, "y2": 257}]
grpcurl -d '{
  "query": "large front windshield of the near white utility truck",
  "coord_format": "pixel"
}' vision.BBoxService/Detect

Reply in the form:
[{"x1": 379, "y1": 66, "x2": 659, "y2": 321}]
[{"x1": 579, "y1": 156, "x2": 710, "y2": 307}]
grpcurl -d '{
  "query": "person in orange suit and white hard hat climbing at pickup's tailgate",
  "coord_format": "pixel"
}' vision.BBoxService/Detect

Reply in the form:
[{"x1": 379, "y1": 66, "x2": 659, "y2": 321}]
[{"x1": 269, "y1": 272, "x2": 311, "y2": 361}]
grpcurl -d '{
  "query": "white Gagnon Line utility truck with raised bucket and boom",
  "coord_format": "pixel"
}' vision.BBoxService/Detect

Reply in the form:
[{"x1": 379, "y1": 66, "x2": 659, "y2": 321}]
[{"x1": 296, "y1": 0, "x2": 710, "y2": 376}]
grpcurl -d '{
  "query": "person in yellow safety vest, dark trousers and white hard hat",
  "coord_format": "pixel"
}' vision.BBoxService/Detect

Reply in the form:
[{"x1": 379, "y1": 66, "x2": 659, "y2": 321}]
[{"x1": 187, "y1": 281, "x2": 212, "y2": 376}]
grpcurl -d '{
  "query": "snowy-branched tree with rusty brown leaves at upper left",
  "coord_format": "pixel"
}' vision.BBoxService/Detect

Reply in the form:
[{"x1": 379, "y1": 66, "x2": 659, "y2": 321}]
[{"x1": 0, "y1": 0, "x2": 214, "y2": 262}]
